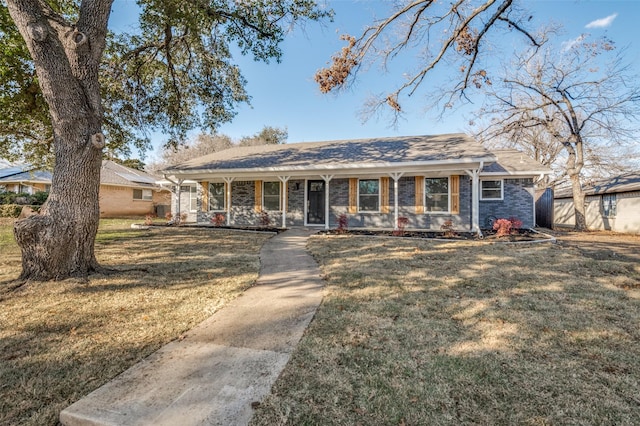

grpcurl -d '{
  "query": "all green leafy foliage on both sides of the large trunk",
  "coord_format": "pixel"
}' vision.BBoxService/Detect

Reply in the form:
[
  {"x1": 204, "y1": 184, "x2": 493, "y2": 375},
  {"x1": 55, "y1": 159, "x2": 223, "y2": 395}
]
[{"x1": 0, "y1": 0, "x2": 332, "y2": 160}]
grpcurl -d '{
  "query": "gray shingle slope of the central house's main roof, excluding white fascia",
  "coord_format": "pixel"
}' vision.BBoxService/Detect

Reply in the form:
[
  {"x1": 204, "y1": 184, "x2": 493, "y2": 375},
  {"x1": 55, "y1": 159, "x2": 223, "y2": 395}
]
[{"x1": 165, "y1": 134, "x2": 493, "y2": 173}]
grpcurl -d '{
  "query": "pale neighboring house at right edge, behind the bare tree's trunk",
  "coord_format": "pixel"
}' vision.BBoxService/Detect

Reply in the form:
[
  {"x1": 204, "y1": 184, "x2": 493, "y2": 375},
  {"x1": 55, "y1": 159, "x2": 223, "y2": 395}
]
[{"x1": 554, "y1": 172, "x2": 640, "y2": 234}]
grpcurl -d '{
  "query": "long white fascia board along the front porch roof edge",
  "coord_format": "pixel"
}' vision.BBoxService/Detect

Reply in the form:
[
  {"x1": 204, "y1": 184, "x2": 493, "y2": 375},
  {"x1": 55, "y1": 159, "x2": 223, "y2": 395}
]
[{"x1": 167, "y1": 157, "x2": 495, "y2": 179}]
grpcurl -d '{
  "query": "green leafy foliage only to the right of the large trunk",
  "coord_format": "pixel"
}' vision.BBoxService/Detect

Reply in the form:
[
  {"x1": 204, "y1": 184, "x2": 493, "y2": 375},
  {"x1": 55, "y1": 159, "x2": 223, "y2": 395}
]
[{"x1": 103, "y1": 0, "x2": 330, "y2": 150}]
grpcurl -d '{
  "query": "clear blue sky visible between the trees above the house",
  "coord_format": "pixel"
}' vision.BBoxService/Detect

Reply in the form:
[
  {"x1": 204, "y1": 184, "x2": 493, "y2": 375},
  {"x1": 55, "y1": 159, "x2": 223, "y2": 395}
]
[{"x1": 107, "y1": 0, "x2": 640, "y2": 155}]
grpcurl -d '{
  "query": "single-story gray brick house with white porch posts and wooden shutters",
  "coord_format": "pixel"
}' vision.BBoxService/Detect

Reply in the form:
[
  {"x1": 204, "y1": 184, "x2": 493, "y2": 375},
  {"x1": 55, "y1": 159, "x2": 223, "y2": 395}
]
[{"x1": 162, "y1": 134, "x2": 550, "y2": 231}]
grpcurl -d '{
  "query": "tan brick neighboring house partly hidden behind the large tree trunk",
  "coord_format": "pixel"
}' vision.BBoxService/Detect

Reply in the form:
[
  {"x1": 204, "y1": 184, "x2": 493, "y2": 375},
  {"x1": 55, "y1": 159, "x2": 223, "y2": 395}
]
[{"x1": 0, "y1": 160, "x2": 171, "y2": 217}]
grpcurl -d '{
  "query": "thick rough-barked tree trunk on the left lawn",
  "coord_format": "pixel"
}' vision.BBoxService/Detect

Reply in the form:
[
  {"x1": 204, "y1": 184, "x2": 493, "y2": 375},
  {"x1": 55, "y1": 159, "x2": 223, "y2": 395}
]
[{"x1": 7, "y1": 0, "x2": 112, "y2": 280}]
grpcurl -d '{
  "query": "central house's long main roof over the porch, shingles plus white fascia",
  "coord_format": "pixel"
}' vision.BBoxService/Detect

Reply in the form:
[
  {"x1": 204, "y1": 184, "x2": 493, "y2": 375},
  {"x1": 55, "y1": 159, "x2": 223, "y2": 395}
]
[{"x1": 163, "y1": 134, "x2": 496, "y2": 179}]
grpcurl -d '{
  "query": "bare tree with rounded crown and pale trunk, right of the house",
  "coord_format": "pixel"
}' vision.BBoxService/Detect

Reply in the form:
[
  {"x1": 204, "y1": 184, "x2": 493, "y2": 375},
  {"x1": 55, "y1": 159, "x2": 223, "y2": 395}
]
[{"x1": 480, "y1": 36, "x2": 640, "y2": 230}]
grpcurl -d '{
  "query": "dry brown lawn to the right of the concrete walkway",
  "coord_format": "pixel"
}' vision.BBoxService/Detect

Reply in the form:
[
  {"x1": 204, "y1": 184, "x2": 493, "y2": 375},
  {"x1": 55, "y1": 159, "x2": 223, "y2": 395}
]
[{"x1": 253, "y1": 236, "x2": 640, "y2": 425}]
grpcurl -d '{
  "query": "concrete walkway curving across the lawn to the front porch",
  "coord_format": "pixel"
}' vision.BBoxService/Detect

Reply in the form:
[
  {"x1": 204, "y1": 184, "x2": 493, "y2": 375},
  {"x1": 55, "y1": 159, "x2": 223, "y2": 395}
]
[{"x1": 60, "y1": 228, "x2": 323, "y2": 426}]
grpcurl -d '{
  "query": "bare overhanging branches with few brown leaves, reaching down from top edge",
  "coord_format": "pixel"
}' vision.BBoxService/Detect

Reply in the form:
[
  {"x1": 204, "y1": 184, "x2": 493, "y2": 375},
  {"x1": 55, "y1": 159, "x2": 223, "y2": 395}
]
[{"x1": 315, "y1": 0, "x2": 545, "y2": 119}]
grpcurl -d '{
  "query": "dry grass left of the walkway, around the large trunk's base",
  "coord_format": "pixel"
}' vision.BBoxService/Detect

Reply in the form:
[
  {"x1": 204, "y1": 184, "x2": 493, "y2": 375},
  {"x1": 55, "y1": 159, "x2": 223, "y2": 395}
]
[{"x1": 0, "y1": 220, "x2": 269, "y2": 425}]
